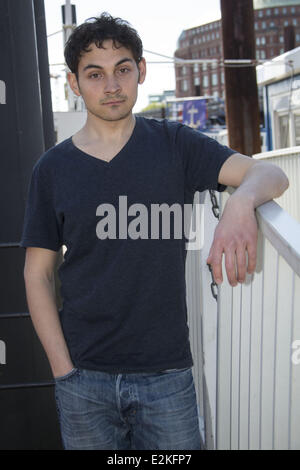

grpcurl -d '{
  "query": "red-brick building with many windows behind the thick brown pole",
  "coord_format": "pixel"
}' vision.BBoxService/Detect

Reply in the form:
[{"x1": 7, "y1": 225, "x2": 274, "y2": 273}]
[{"x1": 174, "y1": 0, "x2": 300, "y2": 98}]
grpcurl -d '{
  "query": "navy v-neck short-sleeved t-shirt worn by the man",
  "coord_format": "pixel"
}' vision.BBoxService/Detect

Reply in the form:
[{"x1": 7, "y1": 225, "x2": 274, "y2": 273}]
[{"x1": 21, "y1": 117, "x2": 234, "y2": 373}]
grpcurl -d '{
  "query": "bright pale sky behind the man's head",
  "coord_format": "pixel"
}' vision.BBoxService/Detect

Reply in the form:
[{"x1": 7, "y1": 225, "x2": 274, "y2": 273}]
[{"x1": 45, "y1": 0, "x2": 221, "y2": 112}]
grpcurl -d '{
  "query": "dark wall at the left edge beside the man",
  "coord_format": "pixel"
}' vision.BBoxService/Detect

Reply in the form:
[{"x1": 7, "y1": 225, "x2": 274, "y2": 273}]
[{"x1": 0, "y1": 0, "x2": 61, "y2": 449}]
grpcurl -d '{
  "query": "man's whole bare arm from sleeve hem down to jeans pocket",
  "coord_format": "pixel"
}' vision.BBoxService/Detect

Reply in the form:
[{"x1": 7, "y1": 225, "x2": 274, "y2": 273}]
[{"x1": 24, "y1": 247, "x2": 74, "y2": 377}]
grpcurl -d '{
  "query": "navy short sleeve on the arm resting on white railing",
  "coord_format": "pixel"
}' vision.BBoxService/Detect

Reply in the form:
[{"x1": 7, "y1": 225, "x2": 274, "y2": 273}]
[{"x1": 176, "y1": 125, "x2": 237, "y2": 193}]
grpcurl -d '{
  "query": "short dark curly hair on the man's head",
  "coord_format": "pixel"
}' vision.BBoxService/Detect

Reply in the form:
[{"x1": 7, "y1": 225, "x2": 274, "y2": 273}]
[{"x1": 64, "y1": 12, "x2": 143, "y2": 79}]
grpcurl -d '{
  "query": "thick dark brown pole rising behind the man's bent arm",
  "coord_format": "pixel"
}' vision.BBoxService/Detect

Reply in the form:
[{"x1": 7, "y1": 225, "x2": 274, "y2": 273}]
[{"x1": 221, "y1": 0, "x2": 261, "y2": 156}]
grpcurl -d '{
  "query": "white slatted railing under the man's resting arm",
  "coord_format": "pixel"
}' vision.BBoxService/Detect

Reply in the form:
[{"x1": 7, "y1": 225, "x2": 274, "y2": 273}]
[{"x1": 187, "y1": 185, "x2": 300, "y2": 449}]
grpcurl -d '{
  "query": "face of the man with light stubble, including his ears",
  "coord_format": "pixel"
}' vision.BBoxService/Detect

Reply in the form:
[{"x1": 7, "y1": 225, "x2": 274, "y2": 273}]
[{"x1": 68, "y1": 40, "x2": 146, "y2": 121}]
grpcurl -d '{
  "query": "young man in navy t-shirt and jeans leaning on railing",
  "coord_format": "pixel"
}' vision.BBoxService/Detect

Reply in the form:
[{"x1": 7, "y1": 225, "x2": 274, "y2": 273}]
[{"x1": 21, "y1": 14, "x2": 288, "y2": 450}]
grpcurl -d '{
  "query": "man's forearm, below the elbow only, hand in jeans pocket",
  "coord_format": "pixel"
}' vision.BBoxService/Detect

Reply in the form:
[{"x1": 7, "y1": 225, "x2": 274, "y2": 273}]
[{"x1": 25, "y1": 276, "x2": 73, "y2": 376}]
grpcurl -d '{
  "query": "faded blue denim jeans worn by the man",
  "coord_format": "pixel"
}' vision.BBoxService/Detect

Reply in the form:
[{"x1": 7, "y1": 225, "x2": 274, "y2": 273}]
[{"x1": 55, "y1": 368, "x2": 201, "y2": 450}]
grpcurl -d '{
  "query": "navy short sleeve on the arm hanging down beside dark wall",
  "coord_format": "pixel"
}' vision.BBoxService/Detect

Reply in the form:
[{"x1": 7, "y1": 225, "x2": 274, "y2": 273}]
[{"x1": 20, "y1": 164, "x2": 63, "y2": 251}]
